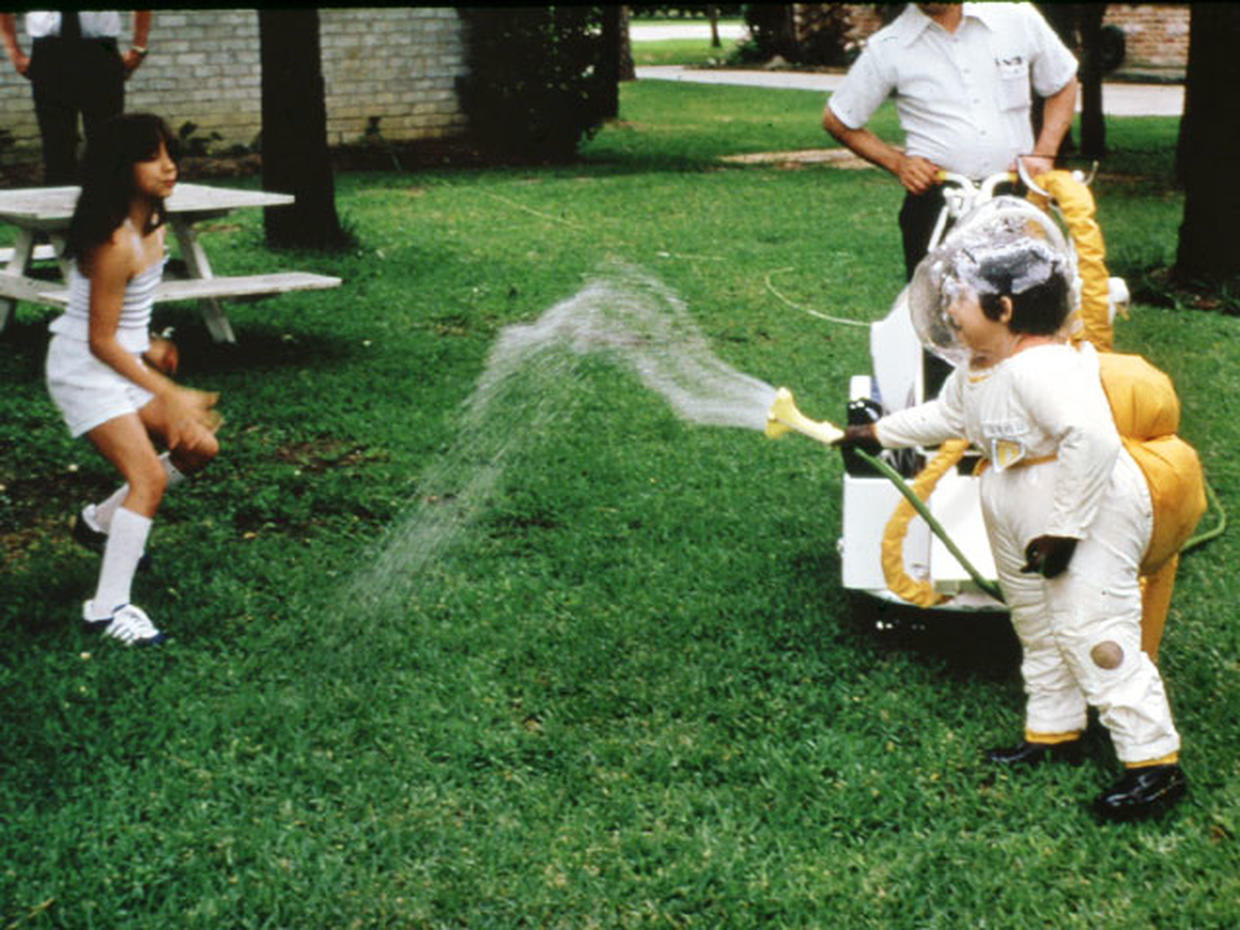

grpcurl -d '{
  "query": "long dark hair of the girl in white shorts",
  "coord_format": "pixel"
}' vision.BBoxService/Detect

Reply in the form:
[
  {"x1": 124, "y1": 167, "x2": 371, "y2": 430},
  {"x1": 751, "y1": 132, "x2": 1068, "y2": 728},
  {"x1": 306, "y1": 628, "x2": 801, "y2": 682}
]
[{"x1": 64, "y1": 113, "x2": 175, "y2": 259}]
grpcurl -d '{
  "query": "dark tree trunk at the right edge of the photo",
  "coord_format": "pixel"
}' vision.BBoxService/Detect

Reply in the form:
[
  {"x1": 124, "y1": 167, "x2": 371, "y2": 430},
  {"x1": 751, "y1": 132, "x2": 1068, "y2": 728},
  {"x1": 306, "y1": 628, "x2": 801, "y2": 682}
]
[{"x1": 1174, "y1": 2, "x2": 1240, "y2": 283}]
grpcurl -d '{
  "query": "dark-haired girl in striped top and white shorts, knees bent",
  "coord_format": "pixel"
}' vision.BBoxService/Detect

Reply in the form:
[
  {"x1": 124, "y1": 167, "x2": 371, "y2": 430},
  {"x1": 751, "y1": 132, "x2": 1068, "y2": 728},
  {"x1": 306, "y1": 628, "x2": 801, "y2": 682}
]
[{"x1": 47, "y1": 114, "x2": 218, "y2": 645}]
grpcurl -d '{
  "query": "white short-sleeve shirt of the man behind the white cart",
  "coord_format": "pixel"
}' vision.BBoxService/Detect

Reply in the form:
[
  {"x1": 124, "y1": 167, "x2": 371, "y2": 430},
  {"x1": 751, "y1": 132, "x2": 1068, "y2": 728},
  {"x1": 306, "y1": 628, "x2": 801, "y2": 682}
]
[{"x1": 827, "y1": 4, "x2": 1076, "y2": 179}]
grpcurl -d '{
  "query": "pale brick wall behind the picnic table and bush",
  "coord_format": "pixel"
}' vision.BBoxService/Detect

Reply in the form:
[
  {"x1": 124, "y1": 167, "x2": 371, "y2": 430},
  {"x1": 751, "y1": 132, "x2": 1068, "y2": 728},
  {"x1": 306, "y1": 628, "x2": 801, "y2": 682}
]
[{"x1": 0, "y1": 6, "x2": 466, "y2": 172}]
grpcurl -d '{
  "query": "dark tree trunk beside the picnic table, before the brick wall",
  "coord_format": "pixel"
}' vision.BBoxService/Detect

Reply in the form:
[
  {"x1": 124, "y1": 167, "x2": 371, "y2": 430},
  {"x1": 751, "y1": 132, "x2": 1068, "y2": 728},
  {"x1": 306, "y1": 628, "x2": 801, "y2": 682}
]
[{"x1": 258, "y1": 9, "x2": 347, "y2": 249}]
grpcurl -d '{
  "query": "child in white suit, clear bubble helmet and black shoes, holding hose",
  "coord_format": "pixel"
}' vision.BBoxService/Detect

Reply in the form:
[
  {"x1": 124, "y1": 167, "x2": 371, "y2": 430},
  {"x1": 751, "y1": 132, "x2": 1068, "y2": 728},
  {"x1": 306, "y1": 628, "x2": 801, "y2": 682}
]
[{"x1": 843, "y1": 228, "x2": 1185, "y2": 820}]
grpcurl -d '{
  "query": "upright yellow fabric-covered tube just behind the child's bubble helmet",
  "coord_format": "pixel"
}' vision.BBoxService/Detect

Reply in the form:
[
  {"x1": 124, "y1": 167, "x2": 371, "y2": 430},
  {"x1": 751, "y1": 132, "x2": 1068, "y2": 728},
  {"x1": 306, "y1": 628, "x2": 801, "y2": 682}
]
[{"x1": 1029, "y1": 170, "x2": 1115, "y2": 352}]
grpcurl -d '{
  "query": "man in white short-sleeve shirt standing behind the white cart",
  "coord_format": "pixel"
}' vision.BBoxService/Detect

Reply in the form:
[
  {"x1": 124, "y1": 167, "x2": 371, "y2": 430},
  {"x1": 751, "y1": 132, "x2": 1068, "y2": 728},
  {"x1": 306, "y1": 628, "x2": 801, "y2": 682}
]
[{"x1": 822, "y1": 4, "x2": 1076, "y2": 278}]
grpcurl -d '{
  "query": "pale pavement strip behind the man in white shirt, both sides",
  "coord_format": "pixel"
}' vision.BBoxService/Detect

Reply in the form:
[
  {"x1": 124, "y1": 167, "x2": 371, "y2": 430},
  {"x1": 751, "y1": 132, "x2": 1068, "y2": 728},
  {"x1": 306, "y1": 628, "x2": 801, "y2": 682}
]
[{"x1": 637, "y1": 64, "x2": 1184, "y2": 117}]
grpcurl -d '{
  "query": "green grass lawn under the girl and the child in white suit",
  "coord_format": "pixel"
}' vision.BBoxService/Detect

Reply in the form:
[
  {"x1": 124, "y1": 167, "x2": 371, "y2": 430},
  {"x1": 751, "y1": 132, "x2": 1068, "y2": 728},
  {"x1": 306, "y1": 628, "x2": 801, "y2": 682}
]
[{"x1": 0, "y1": 82, "x2": 1240, "y2": 930}]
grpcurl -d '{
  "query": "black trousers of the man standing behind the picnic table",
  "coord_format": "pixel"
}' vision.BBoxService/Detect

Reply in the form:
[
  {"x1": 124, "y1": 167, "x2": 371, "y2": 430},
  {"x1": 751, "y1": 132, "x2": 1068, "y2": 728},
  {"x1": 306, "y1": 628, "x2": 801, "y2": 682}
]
[{"x1": 27, "y1": 36, "x2": 125, "y2": 185}]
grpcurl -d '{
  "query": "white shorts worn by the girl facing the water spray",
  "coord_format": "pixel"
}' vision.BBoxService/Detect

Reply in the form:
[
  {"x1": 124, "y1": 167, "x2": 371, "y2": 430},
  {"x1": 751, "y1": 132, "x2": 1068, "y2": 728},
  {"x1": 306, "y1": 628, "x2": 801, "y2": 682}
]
[{"x1": 47, "y1": 335, "x2": 155, "y2": 436}]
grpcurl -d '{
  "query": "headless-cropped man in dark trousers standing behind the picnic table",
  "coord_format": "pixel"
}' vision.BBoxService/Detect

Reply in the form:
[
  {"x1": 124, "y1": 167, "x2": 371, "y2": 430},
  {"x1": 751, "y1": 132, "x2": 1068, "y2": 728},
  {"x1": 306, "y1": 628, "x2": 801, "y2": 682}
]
[{"x1": 0, "y1": 10, "x2": 151, "y2": 185}]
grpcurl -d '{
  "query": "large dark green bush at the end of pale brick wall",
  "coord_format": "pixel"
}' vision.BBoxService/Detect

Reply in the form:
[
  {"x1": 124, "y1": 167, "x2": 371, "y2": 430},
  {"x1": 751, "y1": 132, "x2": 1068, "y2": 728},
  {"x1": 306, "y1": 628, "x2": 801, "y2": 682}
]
[{"x1": 458, "y1": 6, "x2": 616, "y2": 162}]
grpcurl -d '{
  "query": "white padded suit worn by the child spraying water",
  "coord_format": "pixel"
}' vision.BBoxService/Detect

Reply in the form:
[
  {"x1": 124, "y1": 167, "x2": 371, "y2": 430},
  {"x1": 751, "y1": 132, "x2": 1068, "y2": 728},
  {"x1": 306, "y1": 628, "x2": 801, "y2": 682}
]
[{"x1": 877, "y1": 343, "x2": 1179, "y2": 764}]
